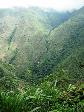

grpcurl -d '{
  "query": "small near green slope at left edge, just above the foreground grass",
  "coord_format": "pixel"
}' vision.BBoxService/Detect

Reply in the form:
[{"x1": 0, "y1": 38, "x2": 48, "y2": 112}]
[{"x1": 0, "y1": 61, "x2": 29, "y2": 93}]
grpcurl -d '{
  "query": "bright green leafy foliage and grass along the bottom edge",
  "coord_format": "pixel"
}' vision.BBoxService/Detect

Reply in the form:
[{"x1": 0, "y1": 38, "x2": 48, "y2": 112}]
[{"x1": 0, "y1": 82, "x2": 84, "y2": 112}]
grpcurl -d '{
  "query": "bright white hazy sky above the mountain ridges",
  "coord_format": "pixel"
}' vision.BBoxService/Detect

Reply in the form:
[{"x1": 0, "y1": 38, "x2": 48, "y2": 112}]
[{"x1": 0, "y1": 0, "x2": 84, "y2": 11}]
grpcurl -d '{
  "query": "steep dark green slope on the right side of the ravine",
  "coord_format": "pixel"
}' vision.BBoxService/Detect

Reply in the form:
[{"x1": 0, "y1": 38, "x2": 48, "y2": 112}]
[{"x1": 48, "y1": 8, "x2": 84, "y2": 79}]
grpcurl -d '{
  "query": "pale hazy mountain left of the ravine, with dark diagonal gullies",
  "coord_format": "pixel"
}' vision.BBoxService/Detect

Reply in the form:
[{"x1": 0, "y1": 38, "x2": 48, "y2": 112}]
[{"x1": 0, "y1": 7, "x2": 70, "y2": 79}]
